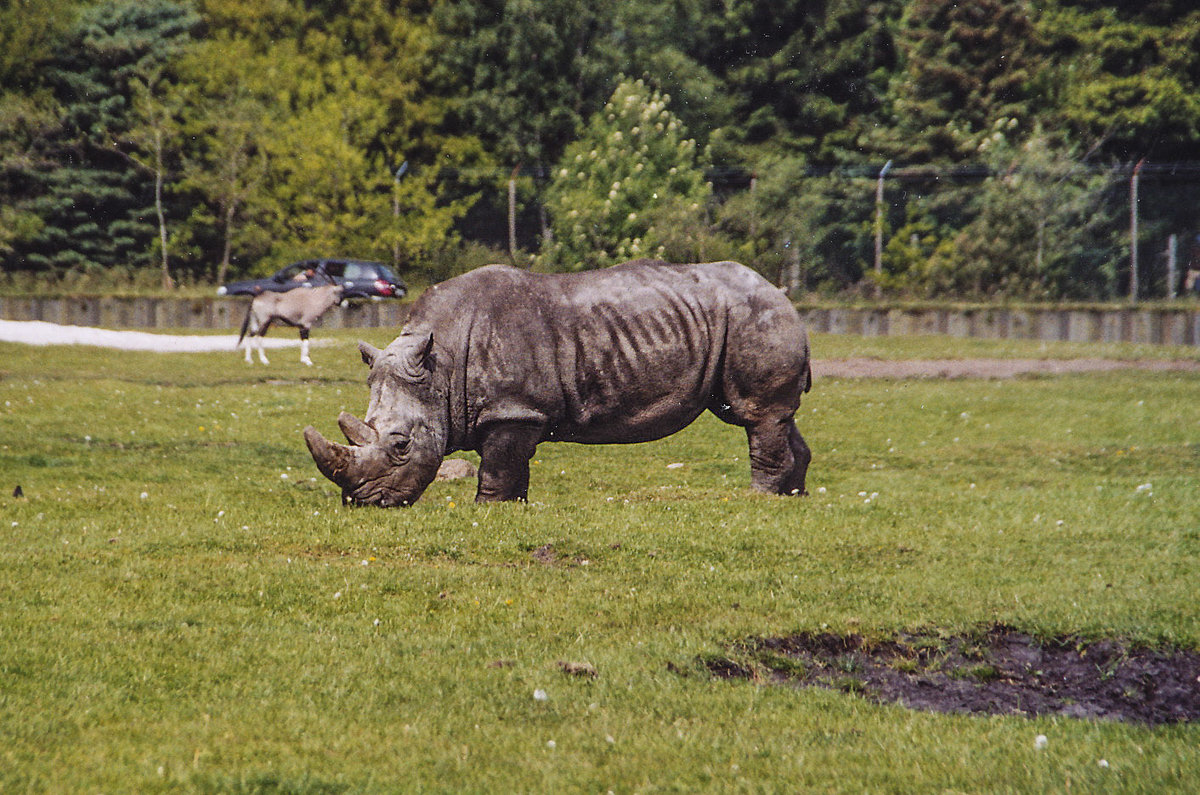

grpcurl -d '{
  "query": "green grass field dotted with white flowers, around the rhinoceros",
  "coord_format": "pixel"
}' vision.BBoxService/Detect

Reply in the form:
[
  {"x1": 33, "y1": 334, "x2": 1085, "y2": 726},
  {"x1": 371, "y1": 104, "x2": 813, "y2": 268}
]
[{"x1": 0, "y1": 330, "x2": 1200, "y2": 794}]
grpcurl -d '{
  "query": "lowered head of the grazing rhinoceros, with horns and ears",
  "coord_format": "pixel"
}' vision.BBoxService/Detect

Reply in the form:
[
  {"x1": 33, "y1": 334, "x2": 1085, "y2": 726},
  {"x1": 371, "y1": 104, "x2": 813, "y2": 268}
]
[{"x1": 304, "y1": 333, "x2": 446, "y2": 508}]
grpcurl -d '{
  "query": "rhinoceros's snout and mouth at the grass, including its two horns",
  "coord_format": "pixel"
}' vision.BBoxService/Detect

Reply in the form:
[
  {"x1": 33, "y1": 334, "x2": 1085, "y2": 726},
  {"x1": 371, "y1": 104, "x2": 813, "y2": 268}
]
[{"x1": 304, "y1": 412, "x2": 440, "y2": 508}]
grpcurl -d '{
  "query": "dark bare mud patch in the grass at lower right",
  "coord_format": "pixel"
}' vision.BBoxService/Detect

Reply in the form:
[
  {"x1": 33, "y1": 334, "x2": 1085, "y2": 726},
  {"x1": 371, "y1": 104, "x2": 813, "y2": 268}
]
[{"x1": 703, "y1": 626, "x2": 1200, "y2": 724}]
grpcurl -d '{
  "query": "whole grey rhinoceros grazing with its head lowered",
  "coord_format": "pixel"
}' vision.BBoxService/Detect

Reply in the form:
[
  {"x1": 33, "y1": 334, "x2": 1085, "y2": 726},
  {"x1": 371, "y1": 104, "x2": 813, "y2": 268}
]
[{"x1": 304, "y1": 261, "x2": 812, "y2": 507}]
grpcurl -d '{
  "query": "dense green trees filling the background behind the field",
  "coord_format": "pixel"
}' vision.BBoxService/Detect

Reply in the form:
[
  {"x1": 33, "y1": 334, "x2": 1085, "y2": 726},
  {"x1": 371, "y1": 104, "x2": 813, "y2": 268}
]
[{"x1": 0, "y1": 0, "x2": 1200, "y2": 298}]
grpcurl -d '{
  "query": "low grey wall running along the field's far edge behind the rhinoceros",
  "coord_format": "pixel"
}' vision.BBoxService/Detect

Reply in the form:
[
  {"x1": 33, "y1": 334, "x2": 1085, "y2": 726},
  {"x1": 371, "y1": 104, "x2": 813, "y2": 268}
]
[{"x1": 0, "y1": 297, "x2": 1200, "y2": 345}]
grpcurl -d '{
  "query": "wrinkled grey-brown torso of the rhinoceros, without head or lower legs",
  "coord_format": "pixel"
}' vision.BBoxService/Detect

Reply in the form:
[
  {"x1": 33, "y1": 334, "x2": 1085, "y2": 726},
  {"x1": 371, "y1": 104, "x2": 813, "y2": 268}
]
[{"x1": 410, "y1": 261, "x2": 808, "y2": 447}]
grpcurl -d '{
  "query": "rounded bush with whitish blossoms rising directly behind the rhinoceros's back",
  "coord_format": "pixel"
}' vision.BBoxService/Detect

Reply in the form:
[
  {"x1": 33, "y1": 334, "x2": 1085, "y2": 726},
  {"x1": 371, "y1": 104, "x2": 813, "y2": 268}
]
[{"x1": 542, "y1": 80, "x2": 712, "y2": 270}]
